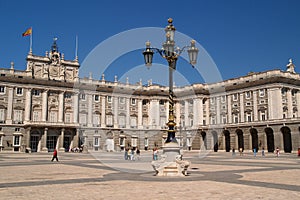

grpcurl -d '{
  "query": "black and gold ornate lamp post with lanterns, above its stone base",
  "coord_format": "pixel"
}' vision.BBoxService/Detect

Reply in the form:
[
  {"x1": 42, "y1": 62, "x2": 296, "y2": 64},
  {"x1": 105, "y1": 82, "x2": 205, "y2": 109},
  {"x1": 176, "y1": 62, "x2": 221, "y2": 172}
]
[{"x1": 143, "y1": 18, "x2": 199, "y2": 143}]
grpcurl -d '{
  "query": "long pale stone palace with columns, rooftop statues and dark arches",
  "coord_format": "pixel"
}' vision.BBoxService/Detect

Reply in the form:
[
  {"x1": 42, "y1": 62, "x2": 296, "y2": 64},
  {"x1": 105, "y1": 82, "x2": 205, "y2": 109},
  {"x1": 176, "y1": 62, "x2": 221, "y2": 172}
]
[{"x1": 0, "y1": 42, "x2": 300, "y2": 153}]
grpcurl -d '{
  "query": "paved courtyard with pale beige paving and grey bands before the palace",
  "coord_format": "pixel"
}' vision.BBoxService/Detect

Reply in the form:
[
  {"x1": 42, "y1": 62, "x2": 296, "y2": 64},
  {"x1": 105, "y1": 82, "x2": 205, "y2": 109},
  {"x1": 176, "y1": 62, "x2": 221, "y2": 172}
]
[{"x1": 0, "y1": 151, "x2": 300, "y2": 200}]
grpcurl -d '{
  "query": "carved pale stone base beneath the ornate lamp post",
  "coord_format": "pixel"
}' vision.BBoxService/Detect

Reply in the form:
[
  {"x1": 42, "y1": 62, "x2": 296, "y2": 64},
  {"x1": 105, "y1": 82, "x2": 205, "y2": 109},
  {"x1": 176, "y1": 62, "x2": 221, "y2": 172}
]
[{"x1": 151, "y1": 142, "x2": 191, "y2": 176}]
